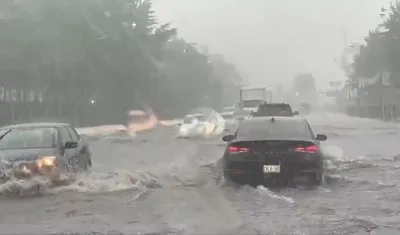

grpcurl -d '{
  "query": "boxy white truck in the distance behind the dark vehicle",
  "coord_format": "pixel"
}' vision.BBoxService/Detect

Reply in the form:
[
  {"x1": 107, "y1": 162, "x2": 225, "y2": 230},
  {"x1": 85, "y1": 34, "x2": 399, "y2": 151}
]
[{"x1": 239, "y1": 87, "x2": 272, "y2": 111}]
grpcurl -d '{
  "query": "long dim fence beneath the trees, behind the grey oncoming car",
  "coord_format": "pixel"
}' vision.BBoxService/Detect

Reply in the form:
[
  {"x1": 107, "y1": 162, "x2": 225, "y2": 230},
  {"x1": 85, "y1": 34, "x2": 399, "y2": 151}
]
[{"x1": 0, "y1": 82, "x2": 126, "y2": 126}]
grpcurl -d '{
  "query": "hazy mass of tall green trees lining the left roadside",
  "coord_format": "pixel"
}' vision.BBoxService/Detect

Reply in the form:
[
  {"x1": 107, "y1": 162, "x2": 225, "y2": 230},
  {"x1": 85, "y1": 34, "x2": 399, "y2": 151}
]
[{"x1": 0, "y1": 0, "x2": 241, "y2": 125}]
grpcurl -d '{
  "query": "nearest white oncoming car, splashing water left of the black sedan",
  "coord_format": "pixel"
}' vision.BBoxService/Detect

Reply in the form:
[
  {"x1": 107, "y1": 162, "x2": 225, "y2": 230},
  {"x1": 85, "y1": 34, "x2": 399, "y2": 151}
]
[{"x1": 176, "y1": 114, "x2": 207, "y2": 138}]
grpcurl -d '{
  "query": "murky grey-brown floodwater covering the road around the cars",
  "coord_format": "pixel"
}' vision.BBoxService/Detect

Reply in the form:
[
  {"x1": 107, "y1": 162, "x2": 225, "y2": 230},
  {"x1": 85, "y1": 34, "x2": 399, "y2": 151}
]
[{"x1": 0, "y1": 114, "x2": 400, "y2": 235}]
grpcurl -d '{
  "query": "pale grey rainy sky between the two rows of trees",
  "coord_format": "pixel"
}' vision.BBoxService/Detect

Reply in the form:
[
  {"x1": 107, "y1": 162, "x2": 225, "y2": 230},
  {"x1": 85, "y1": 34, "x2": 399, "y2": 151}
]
[{"x1": 153, "y1": 0, "x2": 390, "y2": 89}]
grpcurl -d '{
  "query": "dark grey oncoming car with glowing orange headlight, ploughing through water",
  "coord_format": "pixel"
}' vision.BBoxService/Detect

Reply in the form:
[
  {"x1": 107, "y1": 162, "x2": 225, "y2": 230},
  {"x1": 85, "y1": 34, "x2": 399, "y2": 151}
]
[{"x1": 0, "y1": 123, "x2": 92, "y2": 183}]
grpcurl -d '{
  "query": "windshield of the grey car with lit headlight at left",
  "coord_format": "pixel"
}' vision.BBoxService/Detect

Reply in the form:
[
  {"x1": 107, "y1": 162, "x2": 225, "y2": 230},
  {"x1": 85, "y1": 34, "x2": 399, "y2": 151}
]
[{"x1": 0, "y1": 127, "x2": 58, "y2": 150}]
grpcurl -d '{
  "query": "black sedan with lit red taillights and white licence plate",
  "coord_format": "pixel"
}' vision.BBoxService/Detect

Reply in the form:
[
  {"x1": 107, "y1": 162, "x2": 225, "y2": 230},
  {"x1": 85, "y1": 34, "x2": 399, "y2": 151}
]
[{"x1": 222, "y1": 117, "x2": 327, "y2": 186}]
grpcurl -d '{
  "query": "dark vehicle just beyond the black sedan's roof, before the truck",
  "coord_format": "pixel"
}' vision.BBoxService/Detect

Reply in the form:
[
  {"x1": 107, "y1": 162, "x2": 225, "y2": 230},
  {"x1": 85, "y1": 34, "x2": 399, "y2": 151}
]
[{"x1": 252, "y1": 103, "x2": 299, "y2": 117}]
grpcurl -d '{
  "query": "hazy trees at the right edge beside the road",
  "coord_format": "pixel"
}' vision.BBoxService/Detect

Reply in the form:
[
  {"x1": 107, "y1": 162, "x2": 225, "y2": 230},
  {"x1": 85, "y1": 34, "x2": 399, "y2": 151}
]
[{"x1": 349, "y1": 1, "x2": 400, "y2": 119}]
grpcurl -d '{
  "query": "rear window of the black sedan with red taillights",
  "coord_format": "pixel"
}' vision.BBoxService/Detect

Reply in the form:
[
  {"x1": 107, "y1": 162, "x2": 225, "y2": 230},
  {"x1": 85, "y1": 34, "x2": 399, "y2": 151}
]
[{"x1": 237, "y1": 120, "x2": 311, "y2": 140}]
